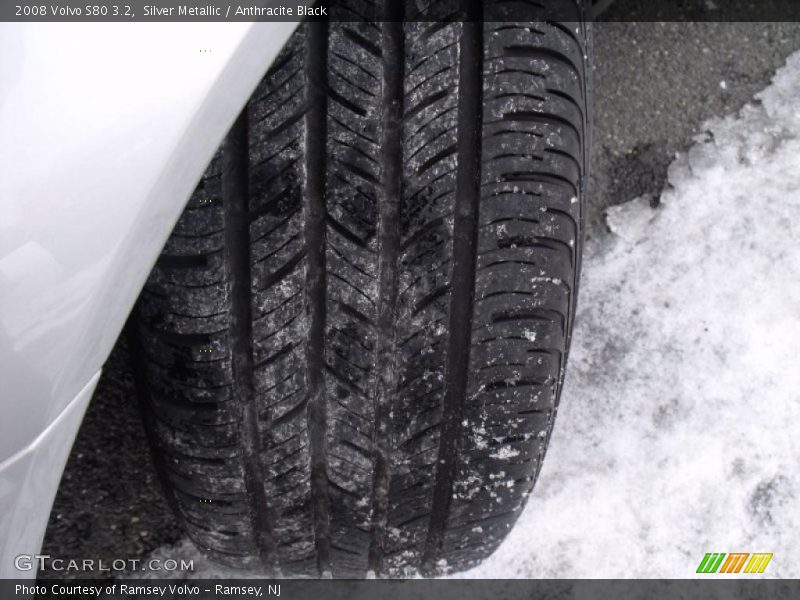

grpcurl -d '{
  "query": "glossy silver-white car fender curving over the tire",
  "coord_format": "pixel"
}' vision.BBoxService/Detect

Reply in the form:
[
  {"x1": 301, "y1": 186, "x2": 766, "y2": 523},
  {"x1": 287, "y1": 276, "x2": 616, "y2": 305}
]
[{"x1": 0, "y1": 22, "x2": 296, "y2": 566}]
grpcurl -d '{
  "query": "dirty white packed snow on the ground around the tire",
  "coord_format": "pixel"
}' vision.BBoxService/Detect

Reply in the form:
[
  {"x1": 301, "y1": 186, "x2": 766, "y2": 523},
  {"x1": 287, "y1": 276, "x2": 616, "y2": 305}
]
[{"x1": 134, "y1": 53, "x2": 800, "y2": 578}]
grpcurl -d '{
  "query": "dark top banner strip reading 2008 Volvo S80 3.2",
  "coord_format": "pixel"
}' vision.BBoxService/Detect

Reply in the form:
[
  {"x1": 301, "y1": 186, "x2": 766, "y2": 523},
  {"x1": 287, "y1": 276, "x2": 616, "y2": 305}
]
[{"x1": 0, "y1": 0, "x2": 800, "y2": 23}]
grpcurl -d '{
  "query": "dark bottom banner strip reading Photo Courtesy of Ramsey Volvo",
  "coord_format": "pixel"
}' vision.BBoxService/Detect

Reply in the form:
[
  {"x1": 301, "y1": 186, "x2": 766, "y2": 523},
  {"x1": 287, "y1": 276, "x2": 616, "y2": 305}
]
[{"x1": 0, "y1": 578, "x2": 800, "y2": 600}]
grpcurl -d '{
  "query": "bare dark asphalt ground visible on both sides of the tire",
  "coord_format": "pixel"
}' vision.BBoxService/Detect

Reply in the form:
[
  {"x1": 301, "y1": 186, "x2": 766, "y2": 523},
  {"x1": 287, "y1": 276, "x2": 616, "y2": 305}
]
[{"x1": 40, "y1": 23, "x2": 800, "y2": 578}]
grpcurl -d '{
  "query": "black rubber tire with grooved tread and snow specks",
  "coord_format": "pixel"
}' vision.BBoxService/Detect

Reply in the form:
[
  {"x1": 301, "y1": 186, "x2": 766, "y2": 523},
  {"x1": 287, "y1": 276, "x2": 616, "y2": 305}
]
[{"x1": 135, "y1": 2, "x2": 588, "y2": 577}]
